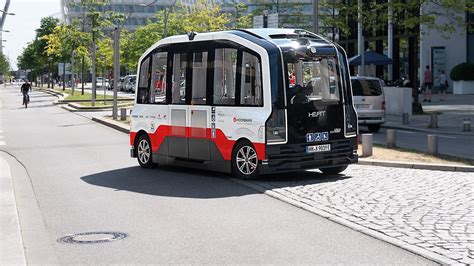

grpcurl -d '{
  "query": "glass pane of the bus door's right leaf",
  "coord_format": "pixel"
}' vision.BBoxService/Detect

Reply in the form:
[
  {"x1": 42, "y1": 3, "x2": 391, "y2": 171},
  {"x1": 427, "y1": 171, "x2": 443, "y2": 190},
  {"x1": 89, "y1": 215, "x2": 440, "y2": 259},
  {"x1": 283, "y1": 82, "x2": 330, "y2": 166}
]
[{"x1": 191, "y1": 52, "x2": 207, "y2": 105}]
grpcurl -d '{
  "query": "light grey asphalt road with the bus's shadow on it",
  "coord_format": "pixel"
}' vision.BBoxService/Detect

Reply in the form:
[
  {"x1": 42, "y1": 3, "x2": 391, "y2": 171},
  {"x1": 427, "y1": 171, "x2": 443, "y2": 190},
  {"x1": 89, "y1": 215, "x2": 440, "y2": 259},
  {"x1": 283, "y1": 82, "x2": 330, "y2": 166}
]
[{"x1": 0, "y1": 87, "x2": 432, "y2": 265}]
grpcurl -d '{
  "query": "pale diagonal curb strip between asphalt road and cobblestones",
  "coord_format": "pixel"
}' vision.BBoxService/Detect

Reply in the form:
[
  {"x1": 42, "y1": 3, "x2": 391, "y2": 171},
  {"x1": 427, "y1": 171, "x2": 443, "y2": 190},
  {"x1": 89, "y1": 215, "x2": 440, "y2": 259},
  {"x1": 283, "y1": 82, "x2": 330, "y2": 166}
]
[{"x1": 231, "y1": 178, "x2": 459, "y2": 265}]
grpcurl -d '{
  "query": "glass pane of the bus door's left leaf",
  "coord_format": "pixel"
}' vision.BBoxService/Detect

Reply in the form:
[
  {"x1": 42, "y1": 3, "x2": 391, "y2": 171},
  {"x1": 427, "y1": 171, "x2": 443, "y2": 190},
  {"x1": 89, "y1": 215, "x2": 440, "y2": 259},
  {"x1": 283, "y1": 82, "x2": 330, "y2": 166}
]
[{"x1": 171, "y1": 53, "x2": 187, "y2": 104}]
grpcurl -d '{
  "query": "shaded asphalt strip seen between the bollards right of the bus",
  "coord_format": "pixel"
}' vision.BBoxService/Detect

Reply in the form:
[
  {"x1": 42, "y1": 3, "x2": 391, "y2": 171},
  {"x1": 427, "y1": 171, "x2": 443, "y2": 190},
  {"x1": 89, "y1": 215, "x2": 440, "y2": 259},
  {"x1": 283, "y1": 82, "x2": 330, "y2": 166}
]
[{"x1": 360, "y1": 126, "x2": 474, "y2": 160}]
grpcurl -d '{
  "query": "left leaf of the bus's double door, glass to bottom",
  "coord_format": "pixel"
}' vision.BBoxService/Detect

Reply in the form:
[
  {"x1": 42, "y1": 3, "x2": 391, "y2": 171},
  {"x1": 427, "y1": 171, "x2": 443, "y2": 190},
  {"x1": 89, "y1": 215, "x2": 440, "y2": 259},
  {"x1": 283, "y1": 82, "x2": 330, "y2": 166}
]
[{"x1": 168, "y1": 53, "x2": 189, "y2": 158}]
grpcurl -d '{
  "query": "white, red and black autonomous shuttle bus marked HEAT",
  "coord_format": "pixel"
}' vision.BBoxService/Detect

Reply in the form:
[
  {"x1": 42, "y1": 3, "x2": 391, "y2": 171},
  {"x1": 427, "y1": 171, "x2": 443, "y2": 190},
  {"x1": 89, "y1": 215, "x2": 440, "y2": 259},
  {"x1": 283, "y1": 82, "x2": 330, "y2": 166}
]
[{"x1": 130, "y1": 29, "x2": 357, "y2": 178}]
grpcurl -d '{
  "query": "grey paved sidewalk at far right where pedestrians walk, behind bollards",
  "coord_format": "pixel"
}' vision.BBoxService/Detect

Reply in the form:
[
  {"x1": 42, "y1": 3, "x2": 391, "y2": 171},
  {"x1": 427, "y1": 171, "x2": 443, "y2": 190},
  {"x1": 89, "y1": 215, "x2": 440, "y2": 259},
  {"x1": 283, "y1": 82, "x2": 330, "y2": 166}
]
[{"x1": 383, "y1": 94, "x2": 474, "y2": 136}]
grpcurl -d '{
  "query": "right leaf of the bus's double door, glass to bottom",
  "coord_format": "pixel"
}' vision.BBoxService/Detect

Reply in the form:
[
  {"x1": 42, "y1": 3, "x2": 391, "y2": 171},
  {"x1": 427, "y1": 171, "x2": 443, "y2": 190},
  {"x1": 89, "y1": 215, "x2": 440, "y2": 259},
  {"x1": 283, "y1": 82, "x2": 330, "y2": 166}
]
[{"x1": 188, "y1": 51, "x2": 211, "y2": 161}]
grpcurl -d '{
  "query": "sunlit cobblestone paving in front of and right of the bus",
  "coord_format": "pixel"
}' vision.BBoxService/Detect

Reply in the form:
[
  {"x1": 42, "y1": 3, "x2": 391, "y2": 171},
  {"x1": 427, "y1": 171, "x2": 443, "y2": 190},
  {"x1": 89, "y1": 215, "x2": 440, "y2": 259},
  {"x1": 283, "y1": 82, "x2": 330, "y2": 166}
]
[{"x1": 244, "y1": 165, "x2": 474, "y2": 264}]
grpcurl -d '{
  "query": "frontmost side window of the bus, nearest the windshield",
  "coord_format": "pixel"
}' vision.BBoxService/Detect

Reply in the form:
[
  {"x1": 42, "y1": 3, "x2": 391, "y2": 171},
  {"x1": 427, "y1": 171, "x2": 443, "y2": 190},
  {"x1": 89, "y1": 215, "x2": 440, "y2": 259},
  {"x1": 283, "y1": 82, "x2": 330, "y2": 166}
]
[{"x1": 240, "y1": 52, "x2": 263, "y2": 106}]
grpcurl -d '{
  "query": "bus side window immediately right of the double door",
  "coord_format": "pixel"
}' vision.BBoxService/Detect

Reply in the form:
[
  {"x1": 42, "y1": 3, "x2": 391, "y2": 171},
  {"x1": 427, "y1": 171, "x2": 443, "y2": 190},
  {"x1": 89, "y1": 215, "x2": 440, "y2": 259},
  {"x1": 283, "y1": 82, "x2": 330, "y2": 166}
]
[{"x1": 213, "y1": 48, "x2": 237, "y2": 105}]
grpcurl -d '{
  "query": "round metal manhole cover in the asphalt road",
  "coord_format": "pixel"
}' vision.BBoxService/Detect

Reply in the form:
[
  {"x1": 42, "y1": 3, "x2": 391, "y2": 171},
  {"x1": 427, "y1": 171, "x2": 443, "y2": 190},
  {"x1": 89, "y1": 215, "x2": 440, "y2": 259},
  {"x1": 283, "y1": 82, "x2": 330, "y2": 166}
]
[{"x1": 58, "y1": 232, "x2": 127, "y2": 244}]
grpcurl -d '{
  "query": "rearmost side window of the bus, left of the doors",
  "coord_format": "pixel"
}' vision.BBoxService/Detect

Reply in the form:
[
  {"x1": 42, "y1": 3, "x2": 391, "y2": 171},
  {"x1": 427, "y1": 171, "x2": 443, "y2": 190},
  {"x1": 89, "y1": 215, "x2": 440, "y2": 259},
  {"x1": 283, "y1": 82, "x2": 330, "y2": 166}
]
[{"x1": 150, "y1": 52, "x2": 168, "y2": 103}]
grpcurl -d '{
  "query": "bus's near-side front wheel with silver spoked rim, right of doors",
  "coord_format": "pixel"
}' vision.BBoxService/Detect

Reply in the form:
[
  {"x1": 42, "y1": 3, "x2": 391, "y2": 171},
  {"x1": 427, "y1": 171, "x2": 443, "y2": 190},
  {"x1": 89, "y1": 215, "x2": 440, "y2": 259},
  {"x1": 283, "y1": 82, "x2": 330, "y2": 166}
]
[{"x1": 232, "y1": 141, "x2": 258, "y2": 179}]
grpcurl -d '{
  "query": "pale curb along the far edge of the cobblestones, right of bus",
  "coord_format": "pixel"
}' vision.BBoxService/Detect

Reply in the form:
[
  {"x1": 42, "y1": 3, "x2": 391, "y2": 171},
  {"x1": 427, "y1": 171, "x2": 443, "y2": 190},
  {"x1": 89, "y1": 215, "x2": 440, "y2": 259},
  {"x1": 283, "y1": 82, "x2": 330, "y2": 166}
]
[{"x1": 358, "y1": 158, "x2": 474, "y2": 172}]
